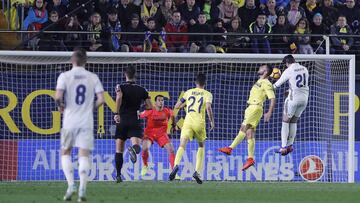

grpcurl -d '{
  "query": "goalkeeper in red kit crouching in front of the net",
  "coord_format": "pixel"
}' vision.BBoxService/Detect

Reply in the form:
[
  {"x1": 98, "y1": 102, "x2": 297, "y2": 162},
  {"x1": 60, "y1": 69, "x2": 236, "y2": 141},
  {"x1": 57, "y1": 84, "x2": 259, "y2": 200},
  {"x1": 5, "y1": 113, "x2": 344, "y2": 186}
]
[{"x1": 140, "y1": 95, "x2": 176, "y2": 176}]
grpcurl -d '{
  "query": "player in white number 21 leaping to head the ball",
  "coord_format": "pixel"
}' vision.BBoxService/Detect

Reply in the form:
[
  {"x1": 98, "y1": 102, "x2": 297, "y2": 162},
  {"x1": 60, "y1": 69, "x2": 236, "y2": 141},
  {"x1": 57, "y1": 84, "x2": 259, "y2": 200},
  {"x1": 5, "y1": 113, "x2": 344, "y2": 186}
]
[{"x1": 274, "y1": 55, "x2": 309, "y2": 156}]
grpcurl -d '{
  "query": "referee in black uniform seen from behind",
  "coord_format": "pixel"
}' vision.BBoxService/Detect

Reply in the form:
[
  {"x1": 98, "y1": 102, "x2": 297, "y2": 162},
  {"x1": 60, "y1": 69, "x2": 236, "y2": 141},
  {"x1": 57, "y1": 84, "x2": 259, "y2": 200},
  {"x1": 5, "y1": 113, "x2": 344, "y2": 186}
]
[{"x1": 114, "y1": 66, "x2": 152, "y2": 182}]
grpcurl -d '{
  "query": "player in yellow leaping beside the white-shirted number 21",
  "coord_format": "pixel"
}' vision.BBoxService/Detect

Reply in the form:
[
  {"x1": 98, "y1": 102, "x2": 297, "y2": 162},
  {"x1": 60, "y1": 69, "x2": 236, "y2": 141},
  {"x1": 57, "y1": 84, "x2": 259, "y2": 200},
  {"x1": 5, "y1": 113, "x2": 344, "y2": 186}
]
[{"x1": 219, "y1": 65, "x2": 275, "y2": 171}]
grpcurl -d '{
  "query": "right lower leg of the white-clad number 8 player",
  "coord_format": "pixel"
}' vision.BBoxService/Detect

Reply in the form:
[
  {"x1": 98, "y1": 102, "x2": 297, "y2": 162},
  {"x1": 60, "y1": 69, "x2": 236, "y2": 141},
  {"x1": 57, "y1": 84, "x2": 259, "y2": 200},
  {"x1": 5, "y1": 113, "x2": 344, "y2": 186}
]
[{"x1": 78, "y1": 148, "x2": 90, "y2": 202}]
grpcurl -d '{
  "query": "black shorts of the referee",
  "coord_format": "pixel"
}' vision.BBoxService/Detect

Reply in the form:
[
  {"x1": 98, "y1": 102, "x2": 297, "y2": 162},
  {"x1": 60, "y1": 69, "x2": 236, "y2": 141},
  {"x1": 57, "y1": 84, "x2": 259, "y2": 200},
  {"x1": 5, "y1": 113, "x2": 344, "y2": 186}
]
[{"x1": 115, "y1": 117, "x2": 143, "y2": 140}]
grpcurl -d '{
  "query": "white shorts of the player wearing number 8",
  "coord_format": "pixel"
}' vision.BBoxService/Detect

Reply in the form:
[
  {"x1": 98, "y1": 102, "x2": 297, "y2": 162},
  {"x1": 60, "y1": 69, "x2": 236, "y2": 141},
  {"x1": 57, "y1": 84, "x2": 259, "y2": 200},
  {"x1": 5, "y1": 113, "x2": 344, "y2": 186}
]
[{"x1": 60, "y1": 128, "x2": 94, "y2": 150}]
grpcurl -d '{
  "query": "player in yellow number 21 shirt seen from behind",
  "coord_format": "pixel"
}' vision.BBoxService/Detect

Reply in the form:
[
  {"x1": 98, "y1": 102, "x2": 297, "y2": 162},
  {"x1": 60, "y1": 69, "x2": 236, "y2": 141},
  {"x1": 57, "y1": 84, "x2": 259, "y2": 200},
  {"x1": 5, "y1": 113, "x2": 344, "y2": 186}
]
[{"x1": 169, "y1": 73, "x2": 215, "y2": 184}]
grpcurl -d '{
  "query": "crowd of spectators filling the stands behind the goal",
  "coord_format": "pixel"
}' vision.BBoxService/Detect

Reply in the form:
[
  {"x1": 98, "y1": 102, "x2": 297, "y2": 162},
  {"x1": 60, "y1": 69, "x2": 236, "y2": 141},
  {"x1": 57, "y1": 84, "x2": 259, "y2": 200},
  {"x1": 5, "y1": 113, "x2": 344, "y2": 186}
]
[{"x1": 0, "y1": 0, "x2": 360, "y2": 54}]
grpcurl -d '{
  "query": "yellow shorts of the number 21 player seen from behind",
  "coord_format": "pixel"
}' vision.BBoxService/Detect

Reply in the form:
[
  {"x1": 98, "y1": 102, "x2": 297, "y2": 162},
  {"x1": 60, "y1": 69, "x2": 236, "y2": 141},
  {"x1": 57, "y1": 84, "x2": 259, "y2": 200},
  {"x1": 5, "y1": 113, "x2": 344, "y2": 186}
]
[{"x1": 181, "y1": 122, "x2": 206, "y2": 142}]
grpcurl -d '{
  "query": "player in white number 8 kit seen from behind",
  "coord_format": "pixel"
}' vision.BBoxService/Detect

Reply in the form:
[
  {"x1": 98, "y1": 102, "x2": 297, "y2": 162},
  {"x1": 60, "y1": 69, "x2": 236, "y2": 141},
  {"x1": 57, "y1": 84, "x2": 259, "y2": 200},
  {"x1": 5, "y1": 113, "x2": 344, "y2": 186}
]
[{"x1": 55, "y1": 49, "x2": 104, "y2": 202}]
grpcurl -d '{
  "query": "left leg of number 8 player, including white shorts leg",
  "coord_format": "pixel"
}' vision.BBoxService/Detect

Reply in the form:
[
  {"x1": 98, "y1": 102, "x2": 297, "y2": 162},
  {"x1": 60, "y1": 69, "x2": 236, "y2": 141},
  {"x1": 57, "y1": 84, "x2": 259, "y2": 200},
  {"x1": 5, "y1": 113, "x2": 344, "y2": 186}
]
[{"x1": 60, "y1": 129, "x2": 76, "y2": 201}]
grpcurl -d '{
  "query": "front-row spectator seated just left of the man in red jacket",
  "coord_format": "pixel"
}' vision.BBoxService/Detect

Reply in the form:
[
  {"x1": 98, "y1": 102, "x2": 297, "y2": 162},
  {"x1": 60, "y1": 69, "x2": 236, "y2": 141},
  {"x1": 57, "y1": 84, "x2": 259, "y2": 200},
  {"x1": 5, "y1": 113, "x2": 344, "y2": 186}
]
[{"x1": 144, "y1": 17, "x2": 167, "y2": 52}]
